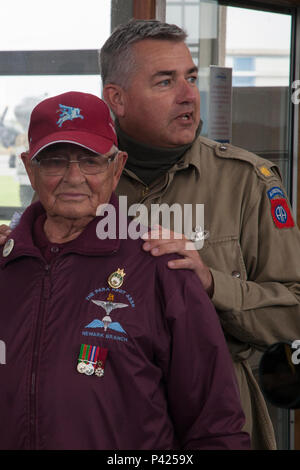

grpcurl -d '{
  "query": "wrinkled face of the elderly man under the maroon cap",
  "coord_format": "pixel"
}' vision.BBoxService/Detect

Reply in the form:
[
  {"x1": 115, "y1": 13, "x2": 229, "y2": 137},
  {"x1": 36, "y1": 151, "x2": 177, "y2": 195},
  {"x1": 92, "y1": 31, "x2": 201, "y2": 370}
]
[{"x1": 22, "y1": 143, "x2": 126, "y2": 219}]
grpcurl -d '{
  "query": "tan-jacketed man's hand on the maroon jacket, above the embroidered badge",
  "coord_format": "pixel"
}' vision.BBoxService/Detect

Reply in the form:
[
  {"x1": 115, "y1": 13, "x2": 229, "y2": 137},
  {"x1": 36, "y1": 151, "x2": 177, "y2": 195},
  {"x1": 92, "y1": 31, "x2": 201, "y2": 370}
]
[{"x1": 142, "y1": 226, "x2": 214, "y2": 297}]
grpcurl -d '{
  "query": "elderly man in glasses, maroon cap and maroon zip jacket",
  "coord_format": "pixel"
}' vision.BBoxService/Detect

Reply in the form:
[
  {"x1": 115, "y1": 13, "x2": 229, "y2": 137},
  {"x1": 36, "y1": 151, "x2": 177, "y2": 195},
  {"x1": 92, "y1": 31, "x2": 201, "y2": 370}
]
[{"x1": 0, "y1": 92, "x2": 249, "y2": 450}]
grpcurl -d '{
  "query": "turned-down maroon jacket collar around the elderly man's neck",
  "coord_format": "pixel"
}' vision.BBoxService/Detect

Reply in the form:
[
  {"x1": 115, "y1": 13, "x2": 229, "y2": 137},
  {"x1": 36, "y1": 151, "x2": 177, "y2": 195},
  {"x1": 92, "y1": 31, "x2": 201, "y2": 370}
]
[{"x1": 0, "y1": 194, "x2": 122, "y2": 267}]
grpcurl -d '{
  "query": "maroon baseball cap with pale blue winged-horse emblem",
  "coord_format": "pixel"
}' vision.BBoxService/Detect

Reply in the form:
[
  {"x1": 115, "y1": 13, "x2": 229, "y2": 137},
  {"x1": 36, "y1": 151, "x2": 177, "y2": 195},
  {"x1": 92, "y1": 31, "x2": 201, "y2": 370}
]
[{"x1": 28, "y1": 91, "x2": 118, "y2": 159}]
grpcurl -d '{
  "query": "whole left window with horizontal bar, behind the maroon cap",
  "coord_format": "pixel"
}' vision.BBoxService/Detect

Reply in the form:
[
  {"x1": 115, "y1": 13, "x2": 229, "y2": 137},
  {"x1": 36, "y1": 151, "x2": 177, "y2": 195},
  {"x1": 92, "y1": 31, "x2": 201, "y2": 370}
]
[{"x1": 0, "y1": 0, "x2": 111, "y2": 224}]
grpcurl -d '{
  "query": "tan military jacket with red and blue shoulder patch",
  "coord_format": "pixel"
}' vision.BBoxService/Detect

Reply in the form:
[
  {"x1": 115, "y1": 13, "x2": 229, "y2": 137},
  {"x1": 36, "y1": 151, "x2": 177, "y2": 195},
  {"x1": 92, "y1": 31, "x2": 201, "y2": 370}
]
[{"x1": 117, "y1": 137, "x2": 300, "y2": 449}]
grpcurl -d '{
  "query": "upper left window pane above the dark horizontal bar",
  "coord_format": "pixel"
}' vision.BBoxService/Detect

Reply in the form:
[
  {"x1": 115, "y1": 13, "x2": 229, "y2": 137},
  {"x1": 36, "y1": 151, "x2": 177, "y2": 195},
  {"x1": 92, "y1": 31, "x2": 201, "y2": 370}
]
[{"x1": 0, "y1": 0, "x2": 111, "y2": 51}]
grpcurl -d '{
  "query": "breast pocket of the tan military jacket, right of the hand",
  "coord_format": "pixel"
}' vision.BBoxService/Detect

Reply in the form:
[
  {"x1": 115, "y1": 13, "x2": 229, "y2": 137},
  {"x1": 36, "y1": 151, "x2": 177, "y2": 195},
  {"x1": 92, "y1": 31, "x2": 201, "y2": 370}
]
[{"x1": 199, "y1": 236, "x2": 247, "y2": 280}]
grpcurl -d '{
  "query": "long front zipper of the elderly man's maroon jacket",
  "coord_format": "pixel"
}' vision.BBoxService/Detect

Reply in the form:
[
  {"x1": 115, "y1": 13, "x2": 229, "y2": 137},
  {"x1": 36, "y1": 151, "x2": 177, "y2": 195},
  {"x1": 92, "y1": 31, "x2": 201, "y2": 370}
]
[{"x1": 29, "y1": 264, "x2": 50, "y2": 450}]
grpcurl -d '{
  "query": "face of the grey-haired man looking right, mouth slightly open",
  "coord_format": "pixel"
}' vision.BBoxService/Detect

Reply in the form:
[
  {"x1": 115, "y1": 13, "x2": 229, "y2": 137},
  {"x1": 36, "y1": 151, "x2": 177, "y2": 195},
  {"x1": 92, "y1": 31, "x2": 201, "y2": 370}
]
[{"x1": 119, "y1": 39, "x2": 200, "y2": 147}]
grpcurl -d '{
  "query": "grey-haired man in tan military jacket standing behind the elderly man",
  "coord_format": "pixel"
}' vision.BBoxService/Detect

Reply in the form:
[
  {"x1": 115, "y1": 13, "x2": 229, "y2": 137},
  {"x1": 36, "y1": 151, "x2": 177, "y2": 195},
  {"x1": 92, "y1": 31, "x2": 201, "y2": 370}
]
[{"x1": 100, "y1": 20, "x2": 300, "y2": 449}]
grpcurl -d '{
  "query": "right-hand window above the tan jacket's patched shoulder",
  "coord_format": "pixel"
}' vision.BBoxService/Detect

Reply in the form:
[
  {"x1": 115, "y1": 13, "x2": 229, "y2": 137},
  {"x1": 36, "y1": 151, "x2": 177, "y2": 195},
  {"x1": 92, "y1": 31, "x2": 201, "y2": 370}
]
[{"x1": 224, "y1": 7, "x2": 292, "y2": 193}]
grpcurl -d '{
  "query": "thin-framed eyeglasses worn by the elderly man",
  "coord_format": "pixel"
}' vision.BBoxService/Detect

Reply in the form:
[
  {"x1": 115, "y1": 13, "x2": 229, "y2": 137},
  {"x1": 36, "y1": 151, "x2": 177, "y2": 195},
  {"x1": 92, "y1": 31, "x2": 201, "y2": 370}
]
[{"x1": 32, "y1": 150, "x2": 119, "y2": 176}]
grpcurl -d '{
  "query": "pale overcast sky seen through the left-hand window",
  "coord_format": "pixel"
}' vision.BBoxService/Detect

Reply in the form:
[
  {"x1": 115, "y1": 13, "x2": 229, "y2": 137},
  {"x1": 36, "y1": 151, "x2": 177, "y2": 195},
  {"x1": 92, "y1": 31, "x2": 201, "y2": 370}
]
[{"x1": 0, "y1": 0, "x2": 111, "y2": 120}]
